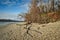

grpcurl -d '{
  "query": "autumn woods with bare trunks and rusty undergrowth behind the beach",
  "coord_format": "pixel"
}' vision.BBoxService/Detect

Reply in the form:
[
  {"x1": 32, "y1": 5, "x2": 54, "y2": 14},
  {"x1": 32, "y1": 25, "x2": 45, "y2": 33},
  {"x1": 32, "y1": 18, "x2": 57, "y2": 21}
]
[{"x1": 19, "y1": 0, "x2": 60, "y2": 24}]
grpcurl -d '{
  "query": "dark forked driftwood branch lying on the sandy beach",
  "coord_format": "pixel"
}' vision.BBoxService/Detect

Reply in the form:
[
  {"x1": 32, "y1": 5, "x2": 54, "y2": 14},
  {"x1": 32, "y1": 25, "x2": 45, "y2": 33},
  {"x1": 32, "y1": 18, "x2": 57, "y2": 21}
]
[{"x1": 16, "y1": 22, "x2": 42, "y2": 40}]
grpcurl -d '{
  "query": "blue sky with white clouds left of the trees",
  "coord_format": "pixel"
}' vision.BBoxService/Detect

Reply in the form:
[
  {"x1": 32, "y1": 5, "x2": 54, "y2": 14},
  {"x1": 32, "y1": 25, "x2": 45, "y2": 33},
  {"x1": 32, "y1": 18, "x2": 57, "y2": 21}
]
[{"x1": 0, "y1": 0, "x2": 30, "y2": 19}]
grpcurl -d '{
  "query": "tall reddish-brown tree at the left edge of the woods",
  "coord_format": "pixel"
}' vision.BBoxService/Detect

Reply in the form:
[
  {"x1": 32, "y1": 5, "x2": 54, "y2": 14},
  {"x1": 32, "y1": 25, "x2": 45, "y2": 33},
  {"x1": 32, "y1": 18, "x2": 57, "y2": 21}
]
[{"x1": 29, "y1": 0, "x2": 40, "y2": 22}]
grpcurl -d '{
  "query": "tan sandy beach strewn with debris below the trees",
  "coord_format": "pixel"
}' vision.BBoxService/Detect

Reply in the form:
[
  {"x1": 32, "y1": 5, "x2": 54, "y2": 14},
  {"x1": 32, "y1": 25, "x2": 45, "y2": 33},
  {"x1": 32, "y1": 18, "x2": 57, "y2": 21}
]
[{"x1": 0, "y1": 21, "x2": 60, "y2": 40}]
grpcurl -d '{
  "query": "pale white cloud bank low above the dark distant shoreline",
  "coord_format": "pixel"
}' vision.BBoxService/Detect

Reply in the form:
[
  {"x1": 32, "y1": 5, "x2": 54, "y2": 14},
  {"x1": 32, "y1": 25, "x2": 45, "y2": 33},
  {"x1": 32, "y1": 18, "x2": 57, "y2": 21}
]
[{"x1": 0, "y1": 13, "x2": 24, "y2": 21}]
